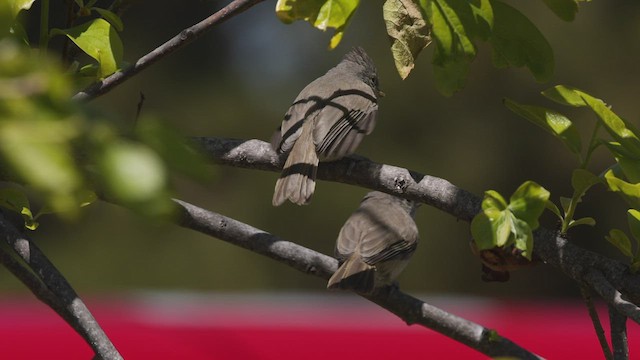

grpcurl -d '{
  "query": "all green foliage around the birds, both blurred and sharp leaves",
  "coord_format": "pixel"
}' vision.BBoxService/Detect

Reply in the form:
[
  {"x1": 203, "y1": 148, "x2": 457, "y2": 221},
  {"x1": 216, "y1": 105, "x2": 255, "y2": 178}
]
[{"x1": 0, "y1": 0, "x2": 640, "y2": 358}]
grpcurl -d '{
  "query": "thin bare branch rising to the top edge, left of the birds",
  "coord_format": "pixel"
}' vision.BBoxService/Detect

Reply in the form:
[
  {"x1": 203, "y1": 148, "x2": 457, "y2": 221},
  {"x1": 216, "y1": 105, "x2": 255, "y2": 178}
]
[{"x1": 73, "y1": 0, "x2": 264, "y2": 101}]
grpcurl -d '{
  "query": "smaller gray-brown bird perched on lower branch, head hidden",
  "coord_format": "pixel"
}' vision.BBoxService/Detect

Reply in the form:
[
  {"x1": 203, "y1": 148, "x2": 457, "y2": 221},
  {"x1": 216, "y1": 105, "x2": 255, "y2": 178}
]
[{"x1": 327, "y1": 191, "x2": 418, "y2": 294}]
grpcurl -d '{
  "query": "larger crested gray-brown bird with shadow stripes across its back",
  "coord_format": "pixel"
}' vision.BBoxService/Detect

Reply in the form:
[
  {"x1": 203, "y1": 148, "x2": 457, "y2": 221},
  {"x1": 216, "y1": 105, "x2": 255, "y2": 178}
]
[{"x1": 271, "y1": 48, "x2": 382, "y2": 206}]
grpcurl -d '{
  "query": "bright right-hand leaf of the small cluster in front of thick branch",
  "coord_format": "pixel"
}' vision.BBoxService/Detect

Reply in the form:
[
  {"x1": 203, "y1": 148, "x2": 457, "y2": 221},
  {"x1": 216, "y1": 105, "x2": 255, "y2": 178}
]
[{"x1": 509, "y1": 181, "x2": 550, "y2": 230}]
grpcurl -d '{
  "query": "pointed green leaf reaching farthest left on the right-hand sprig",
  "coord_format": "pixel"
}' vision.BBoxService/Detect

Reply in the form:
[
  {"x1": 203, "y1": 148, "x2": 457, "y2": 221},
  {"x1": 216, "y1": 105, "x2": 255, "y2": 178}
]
[{"x1": 504, "y1": 99, "x2": 582, "y2": 154}]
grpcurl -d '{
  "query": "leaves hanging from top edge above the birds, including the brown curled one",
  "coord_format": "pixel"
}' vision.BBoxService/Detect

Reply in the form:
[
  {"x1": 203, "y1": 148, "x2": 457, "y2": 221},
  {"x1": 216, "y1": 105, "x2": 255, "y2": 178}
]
[{"x1": 276, "y1": 0, "x2": 592, "y2": 96}]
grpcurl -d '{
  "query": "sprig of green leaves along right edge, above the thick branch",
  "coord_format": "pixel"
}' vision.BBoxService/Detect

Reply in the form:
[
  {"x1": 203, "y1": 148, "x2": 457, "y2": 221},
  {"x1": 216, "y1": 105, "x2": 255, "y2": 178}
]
[{"x1": 505, "y1": 85, "x2": 640, "y2": 271}]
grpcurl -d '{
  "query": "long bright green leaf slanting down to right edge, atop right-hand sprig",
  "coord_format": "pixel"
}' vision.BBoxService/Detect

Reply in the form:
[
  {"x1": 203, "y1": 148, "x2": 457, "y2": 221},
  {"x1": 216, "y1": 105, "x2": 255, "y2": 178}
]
[{"x1": 581, "y1": 93, "x2": 640, "y2": 158}]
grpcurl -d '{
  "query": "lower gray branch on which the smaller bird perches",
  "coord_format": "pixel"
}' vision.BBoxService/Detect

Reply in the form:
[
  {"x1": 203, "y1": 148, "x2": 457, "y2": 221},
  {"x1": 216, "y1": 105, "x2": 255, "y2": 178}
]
[{"x1": 175, "y1": 200, "x2": 539, "y2": 359}]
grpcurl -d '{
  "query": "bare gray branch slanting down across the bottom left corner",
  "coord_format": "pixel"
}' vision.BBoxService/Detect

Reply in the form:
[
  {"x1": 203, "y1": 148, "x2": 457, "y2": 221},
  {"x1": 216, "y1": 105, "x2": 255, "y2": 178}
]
[{"x1": 0, "y1": 214, "x2": 122, "y2": 360}]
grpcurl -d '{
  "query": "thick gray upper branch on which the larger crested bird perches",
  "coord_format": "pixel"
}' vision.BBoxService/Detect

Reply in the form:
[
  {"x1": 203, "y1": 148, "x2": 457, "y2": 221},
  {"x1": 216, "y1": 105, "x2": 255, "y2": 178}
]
[{"x1": 193, "y1": 137, "x2": 640, "y2": 321}]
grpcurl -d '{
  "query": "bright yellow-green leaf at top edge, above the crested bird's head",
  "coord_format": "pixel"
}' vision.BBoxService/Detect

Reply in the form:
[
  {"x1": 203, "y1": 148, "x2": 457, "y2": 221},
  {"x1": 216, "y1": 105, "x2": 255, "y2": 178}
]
[{"x1": 276, "y1": 0, "x2": 360, "y2": 49}]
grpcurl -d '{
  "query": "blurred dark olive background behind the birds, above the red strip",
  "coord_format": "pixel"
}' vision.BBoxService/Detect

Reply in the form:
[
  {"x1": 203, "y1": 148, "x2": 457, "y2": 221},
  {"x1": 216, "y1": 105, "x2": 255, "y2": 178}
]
[{"x1": 0, "y1": 0, "x2": 640, "y2": 298}]
